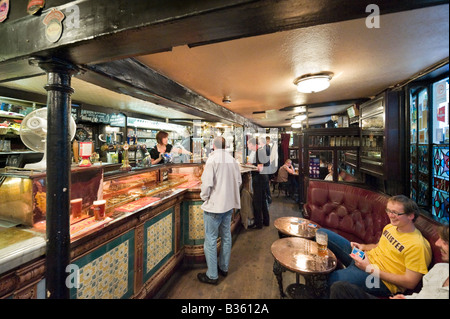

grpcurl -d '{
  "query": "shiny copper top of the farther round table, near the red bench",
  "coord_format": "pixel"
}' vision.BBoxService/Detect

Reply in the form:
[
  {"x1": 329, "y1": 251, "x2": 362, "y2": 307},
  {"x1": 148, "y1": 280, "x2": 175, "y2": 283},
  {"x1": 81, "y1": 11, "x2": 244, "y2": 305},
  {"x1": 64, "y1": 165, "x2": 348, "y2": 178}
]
[{"x1": 274, "y1": 217, "x2": 320, "y2": 238}]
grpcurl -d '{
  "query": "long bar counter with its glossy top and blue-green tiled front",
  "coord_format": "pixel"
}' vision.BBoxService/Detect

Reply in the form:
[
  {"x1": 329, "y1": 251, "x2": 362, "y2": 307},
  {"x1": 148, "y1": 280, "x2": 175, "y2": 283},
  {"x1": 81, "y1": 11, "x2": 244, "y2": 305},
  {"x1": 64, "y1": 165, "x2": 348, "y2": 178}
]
[{"x1": 0, "y1": 164, "x2": 251, "y2": 299}]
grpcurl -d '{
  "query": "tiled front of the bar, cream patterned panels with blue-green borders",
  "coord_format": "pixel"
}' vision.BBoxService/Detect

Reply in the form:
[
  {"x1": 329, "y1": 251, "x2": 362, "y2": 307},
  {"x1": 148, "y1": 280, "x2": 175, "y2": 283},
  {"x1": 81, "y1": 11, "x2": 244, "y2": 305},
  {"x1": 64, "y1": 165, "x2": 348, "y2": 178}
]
[{"x1": 0, "y1": 165, "x2": 246, "y2": 299}]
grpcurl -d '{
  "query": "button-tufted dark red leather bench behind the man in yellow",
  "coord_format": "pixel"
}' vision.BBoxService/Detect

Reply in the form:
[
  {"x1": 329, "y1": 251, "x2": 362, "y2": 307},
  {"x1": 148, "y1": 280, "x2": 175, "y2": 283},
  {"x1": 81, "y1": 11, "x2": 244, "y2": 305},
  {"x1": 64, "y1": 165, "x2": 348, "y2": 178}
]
[{"x1": 303, "y1": 180, "x2": 442, "y2": 268}]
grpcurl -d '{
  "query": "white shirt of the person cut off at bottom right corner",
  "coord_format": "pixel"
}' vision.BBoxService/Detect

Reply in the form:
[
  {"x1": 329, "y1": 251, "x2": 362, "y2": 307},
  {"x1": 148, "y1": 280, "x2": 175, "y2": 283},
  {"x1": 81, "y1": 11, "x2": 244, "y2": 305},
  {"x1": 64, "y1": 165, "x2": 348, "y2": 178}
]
[{"x1": 405, "y1": 263, "x2": 449, "y2": 299}]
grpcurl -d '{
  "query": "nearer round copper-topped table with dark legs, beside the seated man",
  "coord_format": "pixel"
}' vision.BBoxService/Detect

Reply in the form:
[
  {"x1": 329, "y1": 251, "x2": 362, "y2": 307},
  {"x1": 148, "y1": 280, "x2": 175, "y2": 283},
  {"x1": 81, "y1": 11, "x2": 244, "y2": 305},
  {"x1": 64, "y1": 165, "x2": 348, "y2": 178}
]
[{"x1": 271, "y1": 237, "x2": 337, "y2": 298}]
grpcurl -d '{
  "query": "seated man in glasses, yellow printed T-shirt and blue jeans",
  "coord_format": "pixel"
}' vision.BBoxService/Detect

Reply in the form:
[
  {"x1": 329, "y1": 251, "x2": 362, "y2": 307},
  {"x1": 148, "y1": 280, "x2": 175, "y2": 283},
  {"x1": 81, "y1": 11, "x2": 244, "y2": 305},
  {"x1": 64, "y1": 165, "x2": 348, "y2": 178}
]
[{"x1": 326, "y1": 195, "x2": 431, "y2": 296}]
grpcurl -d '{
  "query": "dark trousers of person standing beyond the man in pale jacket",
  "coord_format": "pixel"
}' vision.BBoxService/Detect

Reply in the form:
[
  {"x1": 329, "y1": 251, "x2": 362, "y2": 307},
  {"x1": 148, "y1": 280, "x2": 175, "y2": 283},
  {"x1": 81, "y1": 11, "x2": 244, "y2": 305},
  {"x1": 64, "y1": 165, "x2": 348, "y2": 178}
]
[{"x1": 252, "y1": 174, "x2": 270, "y2": 227}]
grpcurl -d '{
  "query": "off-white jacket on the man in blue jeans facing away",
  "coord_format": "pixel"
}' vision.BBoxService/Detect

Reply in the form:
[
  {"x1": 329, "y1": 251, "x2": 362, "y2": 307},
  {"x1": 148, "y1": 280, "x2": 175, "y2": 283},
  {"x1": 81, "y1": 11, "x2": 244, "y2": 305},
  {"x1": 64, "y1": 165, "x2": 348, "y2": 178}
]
[{"x1": 200, "y1": 149, "x2": 242, "y2": 213}]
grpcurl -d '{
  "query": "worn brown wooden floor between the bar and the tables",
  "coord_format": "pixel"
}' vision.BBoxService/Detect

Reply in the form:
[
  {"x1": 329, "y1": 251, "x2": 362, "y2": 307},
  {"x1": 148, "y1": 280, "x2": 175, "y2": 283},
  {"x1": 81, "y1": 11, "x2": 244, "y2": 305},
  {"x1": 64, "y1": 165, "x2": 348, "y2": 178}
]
[{"x1": 155, "y1": 192, "x2": 302, "y2": 299}]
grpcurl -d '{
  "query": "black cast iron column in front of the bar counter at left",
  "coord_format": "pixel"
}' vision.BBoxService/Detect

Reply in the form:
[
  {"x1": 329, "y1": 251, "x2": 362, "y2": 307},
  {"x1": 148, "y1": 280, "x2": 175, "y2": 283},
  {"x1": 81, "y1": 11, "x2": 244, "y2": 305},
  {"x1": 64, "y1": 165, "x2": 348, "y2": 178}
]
[{"x1": 34, "y1": 59, "x2": 78, "y2": 299}]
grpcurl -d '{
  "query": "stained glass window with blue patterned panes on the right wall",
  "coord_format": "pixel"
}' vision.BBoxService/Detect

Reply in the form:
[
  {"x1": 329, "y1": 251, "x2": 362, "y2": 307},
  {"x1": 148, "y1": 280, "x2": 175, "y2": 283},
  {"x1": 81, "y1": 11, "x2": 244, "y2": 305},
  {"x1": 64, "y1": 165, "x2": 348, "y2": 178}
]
[{"x1": 409, "y1": 78, "x2": 450, "y2": 223}]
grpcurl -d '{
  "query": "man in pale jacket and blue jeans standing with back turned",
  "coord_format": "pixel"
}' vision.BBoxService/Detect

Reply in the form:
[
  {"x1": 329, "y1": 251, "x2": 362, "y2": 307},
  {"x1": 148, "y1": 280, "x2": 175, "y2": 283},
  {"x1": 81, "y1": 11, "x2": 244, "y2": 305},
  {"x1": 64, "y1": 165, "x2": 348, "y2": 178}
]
[{"x1": 197, "y1": 136, "x2": 242, "y2": 285}]
